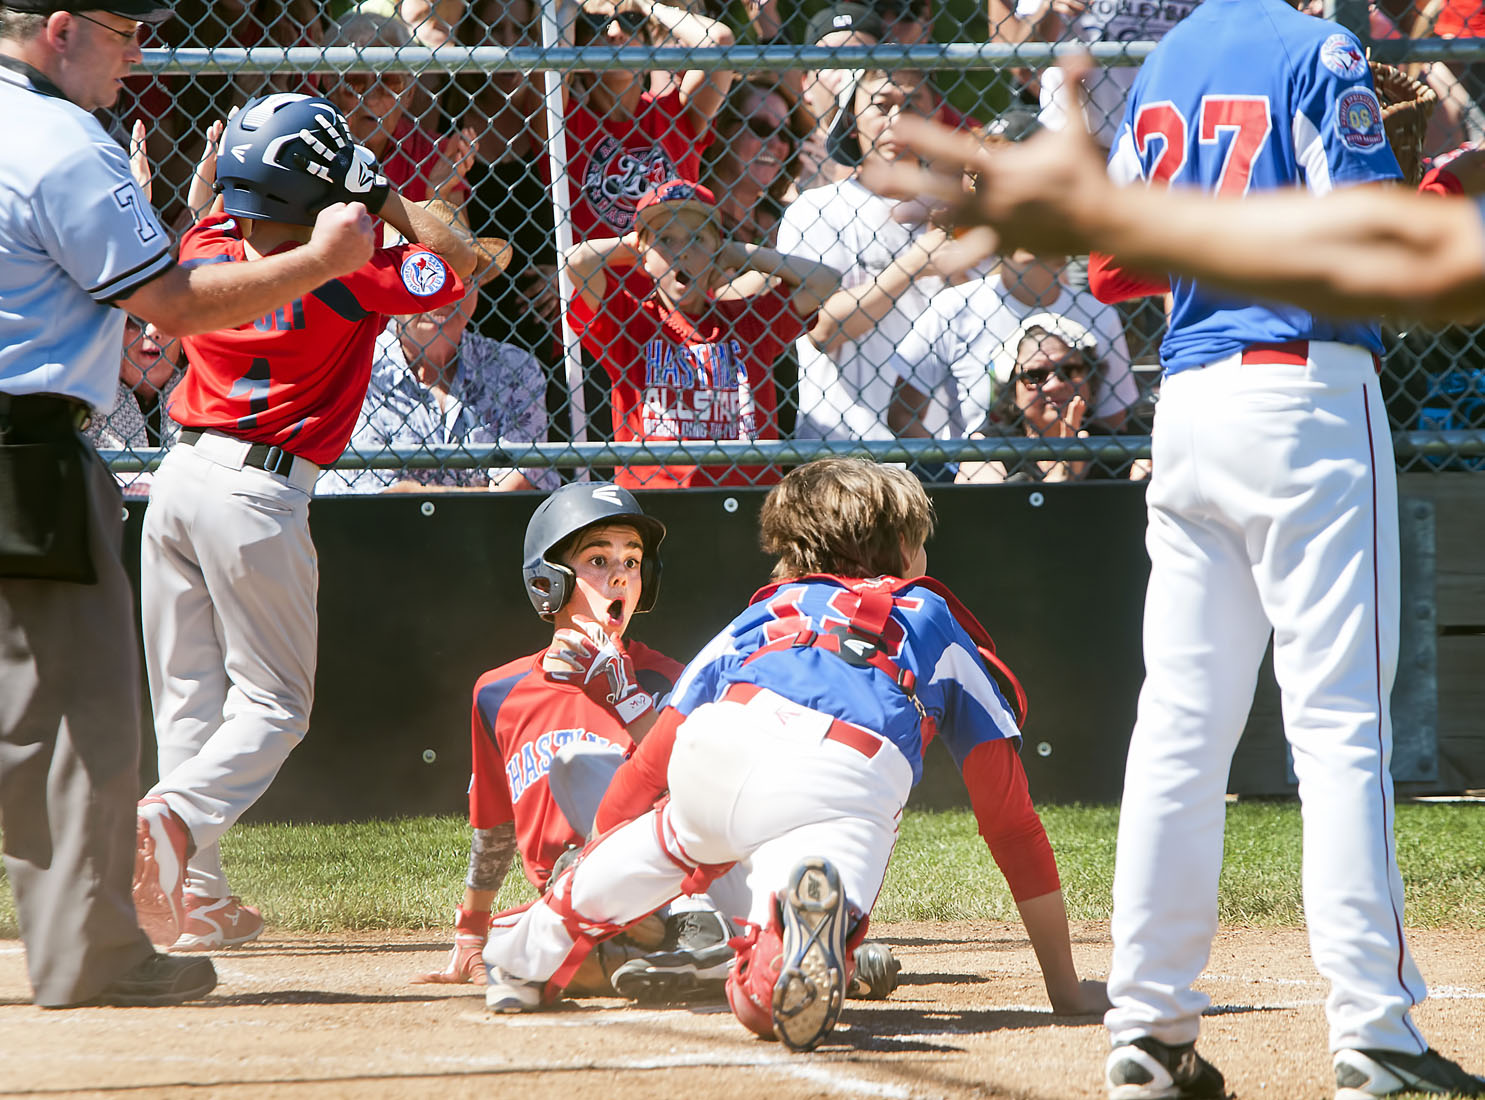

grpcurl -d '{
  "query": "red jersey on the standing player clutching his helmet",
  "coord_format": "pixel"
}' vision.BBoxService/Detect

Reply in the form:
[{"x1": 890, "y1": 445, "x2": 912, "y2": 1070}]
[{"x1": 169, "y1": 214, "x2": 465, "y2": 466}]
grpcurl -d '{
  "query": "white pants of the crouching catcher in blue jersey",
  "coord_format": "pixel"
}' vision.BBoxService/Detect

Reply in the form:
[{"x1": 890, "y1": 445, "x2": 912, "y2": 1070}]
[{"x1": 484, "y1": 692, "x2": 912, "y2": 981}]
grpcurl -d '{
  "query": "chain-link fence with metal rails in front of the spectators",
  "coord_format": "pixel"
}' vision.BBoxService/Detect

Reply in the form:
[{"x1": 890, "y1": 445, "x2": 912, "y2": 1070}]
[{"x1": 94, "y1": 0, "x2": 1485, "y2": 491}]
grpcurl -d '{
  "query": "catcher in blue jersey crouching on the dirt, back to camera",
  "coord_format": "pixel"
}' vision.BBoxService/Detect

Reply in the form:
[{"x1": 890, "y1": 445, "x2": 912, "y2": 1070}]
[{"x1": 484, "y1": 459, "x2": 1108, "y2": 1050}]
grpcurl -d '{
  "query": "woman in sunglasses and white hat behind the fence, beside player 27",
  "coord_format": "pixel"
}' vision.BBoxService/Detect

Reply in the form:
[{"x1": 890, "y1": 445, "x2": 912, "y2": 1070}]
[{"x1": 955, "y1": 313, "x2": 1102, "y2": 482}]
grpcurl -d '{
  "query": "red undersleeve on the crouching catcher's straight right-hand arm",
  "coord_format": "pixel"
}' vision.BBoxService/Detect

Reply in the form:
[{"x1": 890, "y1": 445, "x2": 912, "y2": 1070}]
[{"x1": 962, "y1": 739, "x2": 1060, "y2": 901}]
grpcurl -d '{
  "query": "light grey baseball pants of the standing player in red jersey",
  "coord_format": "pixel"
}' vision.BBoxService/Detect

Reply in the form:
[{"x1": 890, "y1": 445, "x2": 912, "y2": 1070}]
[{"x1": 140, "y1": 435, "x2": 319, "y2": 897}]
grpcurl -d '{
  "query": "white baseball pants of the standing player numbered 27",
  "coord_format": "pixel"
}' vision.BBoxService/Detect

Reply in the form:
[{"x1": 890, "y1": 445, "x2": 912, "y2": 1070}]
[{"x1": 1106, "y1": 343, "x2": 1426, "y2": 1052}]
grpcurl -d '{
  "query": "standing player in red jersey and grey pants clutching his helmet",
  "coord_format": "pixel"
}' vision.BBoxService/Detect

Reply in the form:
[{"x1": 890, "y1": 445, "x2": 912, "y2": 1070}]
[{"x1": 134, "y1": 94, "x2": 475, "y2": 950}]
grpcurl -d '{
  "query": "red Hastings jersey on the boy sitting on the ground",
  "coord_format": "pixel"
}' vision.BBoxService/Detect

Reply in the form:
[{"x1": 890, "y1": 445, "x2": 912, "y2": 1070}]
[{"x1": 469, "y1": 641, "x2": 680, "y2": 889}]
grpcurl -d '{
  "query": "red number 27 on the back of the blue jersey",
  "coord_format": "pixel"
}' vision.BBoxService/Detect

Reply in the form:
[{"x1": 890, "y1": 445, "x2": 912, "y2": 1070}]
[{"x1": 1135, "y1": 95, "x2": 1274, "y2": 197}]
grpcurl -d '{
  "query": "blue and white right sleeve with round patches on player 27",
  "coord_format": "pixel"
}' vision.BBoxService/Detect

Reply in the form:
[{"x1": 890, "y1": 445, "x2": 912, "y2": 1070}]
[{"x1": 1293, "y1": 28, "x2": 1402, "y2": 194}]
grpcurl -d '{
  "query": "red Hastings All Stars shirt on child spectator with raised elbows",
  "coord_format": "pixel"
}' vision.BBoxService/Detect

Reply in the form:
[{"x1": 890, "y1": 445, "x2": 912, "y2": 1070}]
[{"x1": 572, "y1": 278, "x2": 809, "y2": 488}]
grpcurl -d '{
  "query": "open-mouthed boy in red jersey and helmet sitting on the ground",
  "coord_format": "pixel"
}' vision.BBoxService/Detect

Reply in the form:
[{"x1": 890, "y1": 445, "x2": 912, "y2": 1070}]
[{"x1": 414, "y1": 482, "x2": 726, "y2": 993}]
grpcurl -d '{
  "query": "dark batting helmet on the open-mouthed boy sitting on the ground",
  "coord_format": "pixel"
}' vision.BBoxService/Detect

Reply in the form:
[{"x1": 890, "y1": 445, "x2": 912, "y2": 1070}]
[{"x1": 521, "y1": 481, "x2": 665, "y2": 619}]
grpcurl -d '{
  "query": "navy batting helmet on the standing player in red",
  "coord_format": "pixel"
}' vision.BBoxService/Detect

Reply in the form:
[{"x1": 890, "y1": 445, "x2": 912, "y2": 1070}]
[{"x1": 217, "y1": 92, "x2": 350, "y2": 226}]
